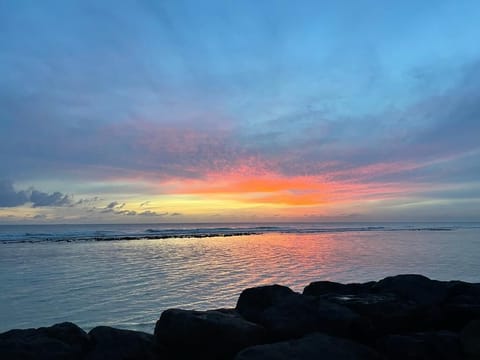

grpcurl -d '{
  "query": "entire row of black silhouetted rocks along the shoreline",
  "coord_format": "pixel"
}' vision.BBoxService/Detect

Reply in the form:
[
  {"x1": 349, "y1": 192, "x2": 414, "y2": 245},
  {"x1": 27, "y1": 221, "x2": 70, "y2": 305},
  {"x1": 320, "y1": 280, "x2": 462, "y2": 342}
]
[{"x1": 0, "y1": 275, "x2": 480, "y2": 360}]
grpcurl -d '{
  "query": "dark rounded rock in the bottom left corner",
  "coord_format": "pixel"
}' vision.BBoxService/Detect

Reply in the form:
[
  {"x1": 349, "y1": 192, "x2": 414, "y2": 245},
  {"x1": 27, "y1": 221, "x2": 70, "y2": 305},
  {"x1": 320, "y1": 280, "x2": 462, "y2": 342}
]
[{"x1": 0, "y1": 322, "x2": 90, "y2": 360}]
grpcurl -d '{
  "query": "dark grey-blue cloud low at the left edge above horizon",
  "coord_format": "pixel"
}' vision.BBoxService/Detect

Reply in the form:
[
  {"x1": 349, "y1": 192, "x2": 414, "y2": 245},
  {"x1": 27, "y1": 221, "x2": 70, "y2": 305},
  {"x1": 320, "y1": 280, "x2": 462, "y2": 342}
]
[{"x1": 0, "y1": 180, "x2": 72, "y2": 207}]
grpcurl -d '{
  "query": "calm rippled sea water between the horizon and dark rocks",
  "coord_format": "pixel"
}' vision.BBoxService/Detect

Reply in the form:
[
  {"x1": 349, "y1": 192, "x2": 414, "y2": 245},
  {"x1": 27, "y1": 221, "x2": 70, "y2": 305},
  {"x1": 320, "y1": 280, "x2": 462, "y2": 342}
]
[{"x1": 0, "y1": 224, "x2": 480, "y2": 332}]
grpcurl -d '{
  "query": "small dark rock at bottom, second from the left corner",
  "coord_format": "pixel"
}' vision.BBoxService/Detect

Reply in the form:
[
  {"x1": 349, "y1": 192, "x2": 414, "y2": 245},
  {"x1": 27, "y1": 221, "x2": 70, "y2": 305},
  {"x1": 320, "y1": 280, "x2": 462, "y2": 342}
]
[{"x1": 85, "y1": 326, "x2": 156, "y2": 360}]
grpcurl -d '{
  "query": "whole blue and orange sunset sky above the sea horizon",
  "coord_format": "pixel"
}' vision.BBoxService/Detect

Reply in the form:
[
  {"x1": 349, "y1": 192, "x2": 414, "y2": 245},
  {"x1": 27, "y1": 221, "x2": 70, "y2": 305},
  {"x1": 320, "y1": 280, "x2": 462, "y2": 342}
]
[{"x1": 0, "y1": 0, "x2": 480, "y2": 224}]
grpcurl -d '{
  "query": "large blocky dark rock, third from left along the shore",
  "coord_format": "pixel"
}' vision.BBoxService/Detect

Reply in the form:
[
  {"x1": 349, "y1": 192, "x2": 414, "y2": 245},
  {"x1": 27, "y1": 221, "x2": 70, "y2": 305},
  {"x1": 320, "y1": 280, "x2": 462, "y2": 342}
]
[{"x1": 155, "y1": 309, "x2": 266, "y2": 359}]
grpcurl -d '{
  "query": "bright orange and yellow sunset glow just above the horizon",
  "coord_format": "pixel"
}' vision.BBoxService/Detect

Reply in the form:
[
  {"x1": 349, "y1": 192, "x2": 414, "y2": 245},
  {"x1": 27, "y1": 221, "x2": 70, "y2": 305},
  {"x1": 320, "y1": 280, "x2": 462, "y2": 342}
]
[{"x1": 68, "y1": 163, "x2": 438, "y2": 220}]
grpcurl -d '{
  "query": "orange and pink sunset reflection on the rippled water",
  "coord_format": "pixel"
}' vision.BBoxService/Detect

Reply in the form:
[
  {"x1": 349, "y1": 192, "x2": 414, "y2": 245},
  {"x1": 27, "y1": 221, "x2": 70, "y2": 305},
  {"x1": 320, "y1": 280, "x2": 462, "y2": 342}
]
[{"x1": 142, "y1": 233, "x2": 352, "y2": 296}]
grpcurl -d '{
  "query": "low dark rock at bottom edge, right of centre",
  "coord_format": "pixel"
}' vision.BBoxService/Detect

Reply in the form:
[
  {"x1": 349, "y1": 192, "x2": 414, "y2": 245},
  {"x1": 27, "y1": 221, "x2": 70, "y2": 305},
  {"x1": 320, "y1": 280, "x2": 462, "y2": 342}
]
[{"x1": 235, "y1": 333, "x2": 381, "y2": 360}]
